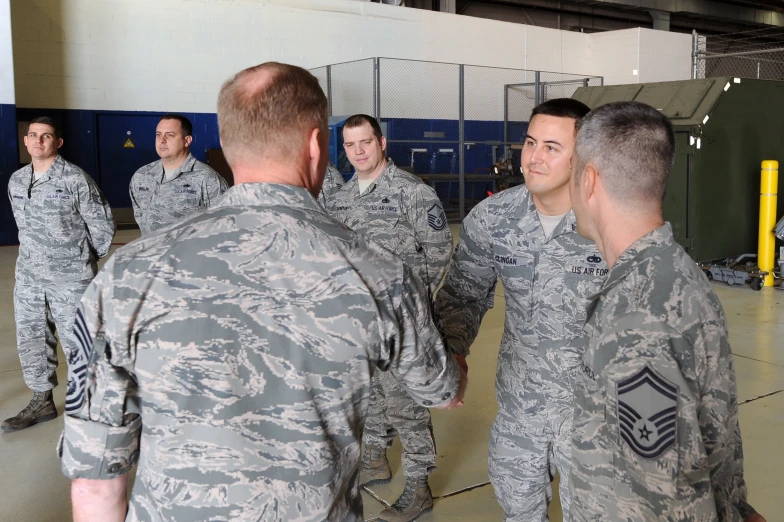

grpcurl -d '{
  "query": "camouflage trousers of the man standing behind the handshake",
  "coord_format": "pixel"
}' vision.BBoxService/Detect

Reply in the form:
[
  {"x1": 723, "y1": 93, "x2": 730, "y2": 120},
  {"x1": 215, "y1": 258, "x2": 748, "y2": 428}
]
[{"x1": 362, "y1": 371, "x2": 436, "y2": 478}]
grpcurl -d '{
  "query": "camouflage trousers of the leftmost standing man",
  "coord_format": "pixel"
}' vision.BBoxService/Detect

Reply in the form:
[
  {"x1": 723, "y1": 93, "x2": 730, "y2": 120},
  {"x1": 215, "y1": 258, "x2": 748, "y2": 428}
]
[{"x1": 14, "y1": 281, "x2": 89, "y2": 392}]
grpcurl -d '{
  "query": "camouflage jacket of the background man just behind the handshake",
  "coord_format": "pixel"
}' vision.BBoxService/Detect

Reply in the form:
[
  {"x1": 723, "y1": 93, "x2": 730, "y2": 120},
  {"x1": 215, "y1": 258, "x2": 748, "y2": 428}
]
[{"x1": 330, "y1": 160, "x2": 452, "y2": 294}]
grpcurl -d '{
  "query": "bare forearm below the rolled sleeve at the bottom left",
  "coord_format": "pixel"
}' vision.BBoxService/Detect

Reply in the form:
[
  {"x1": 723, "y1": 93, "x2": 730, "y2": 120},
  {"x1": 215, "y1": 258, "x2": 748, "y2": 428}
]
[{"x1": 71, "y1": 473, "x2": 128, "y2": 522}]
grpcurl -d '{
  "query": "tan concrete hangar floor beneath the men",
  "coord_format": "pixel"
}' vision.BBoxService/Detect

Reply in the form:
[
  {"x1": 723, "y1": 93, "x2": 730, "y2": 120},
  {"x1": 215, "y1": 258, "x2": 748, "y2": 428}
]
[{"x1": 0, "y1": 226, "x2": 784, "y2": 522}]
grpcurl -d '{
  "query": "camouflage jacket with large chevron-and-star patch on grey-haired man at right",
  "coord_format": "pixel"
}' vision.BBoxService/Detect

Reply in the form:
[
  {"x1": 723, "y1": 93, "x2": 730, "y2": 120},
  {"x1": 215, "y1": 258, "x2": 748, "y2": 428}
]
[{"x1": 572, "y1": 223, "x2": 754, "y2": 522}]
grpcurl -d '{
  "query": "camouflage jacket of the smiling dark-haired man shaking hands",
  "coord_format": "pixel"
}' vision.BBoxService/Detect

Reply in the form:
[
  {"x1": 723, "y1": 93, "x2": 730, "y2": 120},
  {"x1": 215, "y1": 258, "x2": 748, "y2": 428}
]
[{"x1": 436, "y1": 186, "x2": 607, "y2": 411}]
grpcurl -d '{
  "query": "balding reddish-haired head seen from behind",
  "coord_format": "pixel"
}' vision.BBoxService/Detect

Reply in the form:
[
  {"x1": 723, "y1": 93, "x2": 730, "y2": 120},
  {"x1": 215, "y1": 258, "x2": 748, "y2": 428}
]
[{"x1": 218, "y1": 62, "x2": 328, "y2": 168}]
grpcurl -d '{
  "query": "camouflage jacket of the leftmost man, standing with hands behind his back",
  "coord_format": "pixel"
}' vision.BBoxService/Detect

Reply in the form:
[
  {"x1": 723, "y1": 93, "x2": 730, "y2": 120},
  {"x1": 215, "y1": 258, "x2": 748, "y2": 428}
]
[{"x1": 8, "y1": 155, "x2": 115, "y2": 283}]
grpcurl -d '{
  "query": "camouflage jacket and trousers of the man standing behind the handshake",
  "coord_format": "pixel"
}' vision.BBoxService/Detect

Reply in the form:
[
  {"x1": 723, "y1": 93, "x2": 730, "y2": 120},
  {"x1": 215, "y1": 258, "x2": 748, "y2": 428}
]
[{"x1": 332, "y1": 161, "x2": 452, "y2": 478}]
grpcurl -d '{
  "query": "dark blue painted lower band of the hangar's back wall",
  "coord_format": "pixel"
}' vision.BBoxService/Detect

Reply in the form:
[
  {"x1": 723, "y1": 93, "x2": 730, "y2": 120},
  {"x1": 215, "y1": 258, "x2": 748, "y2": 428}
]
[{"x1": 0, "y1": 109, "x2": 528, "y2": 244}]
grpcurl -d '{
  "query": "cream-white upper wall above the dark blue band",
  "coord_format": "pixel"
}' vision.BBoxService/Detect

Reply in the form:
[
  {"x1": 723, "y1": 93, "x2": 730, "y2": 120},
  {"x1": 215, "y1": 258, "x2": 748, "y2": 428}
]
[{"x1": 10, "y1": 0, "x2": 689, "y2": 119}]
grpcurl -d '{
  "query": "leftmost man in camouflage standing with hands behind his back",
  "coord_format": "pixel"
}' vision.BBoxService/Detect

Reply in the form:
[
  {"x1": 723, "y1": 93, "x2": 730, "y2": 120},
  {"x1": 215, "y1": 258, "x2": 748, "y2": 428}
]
[{"x1": 2, "y1": 117, "x2": 114, "y2": 431}]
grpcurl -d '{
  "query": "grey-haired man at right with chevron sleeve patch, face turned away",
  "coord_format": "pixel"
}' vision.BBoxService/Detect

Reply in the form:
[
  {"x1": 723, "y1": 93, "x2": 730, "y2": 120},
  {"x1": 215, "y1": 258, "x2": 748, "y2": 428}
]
[{"x1": 570, "y1": 102, "x2": 764, "y2": 522}]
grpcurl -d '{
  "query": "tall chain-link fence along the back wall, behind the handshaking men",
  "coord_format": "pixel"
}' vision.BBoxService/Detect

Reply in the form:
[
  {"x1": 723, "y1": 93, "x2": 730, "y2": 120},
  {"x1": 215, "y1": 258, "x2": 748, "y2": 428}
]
[{"x1": 311, "y1": 58, "x2": 603, "y2": 220}]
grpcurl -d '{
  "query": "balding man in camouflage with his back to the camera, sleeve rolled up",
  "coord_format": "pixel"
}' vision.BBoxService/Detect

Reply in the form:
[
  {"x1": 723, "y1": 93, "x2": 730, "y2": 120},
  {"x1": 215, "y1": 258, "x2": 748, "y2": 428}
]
[{"x1": 60, "y1": 63, "x2": 464, "y2": 522}]
